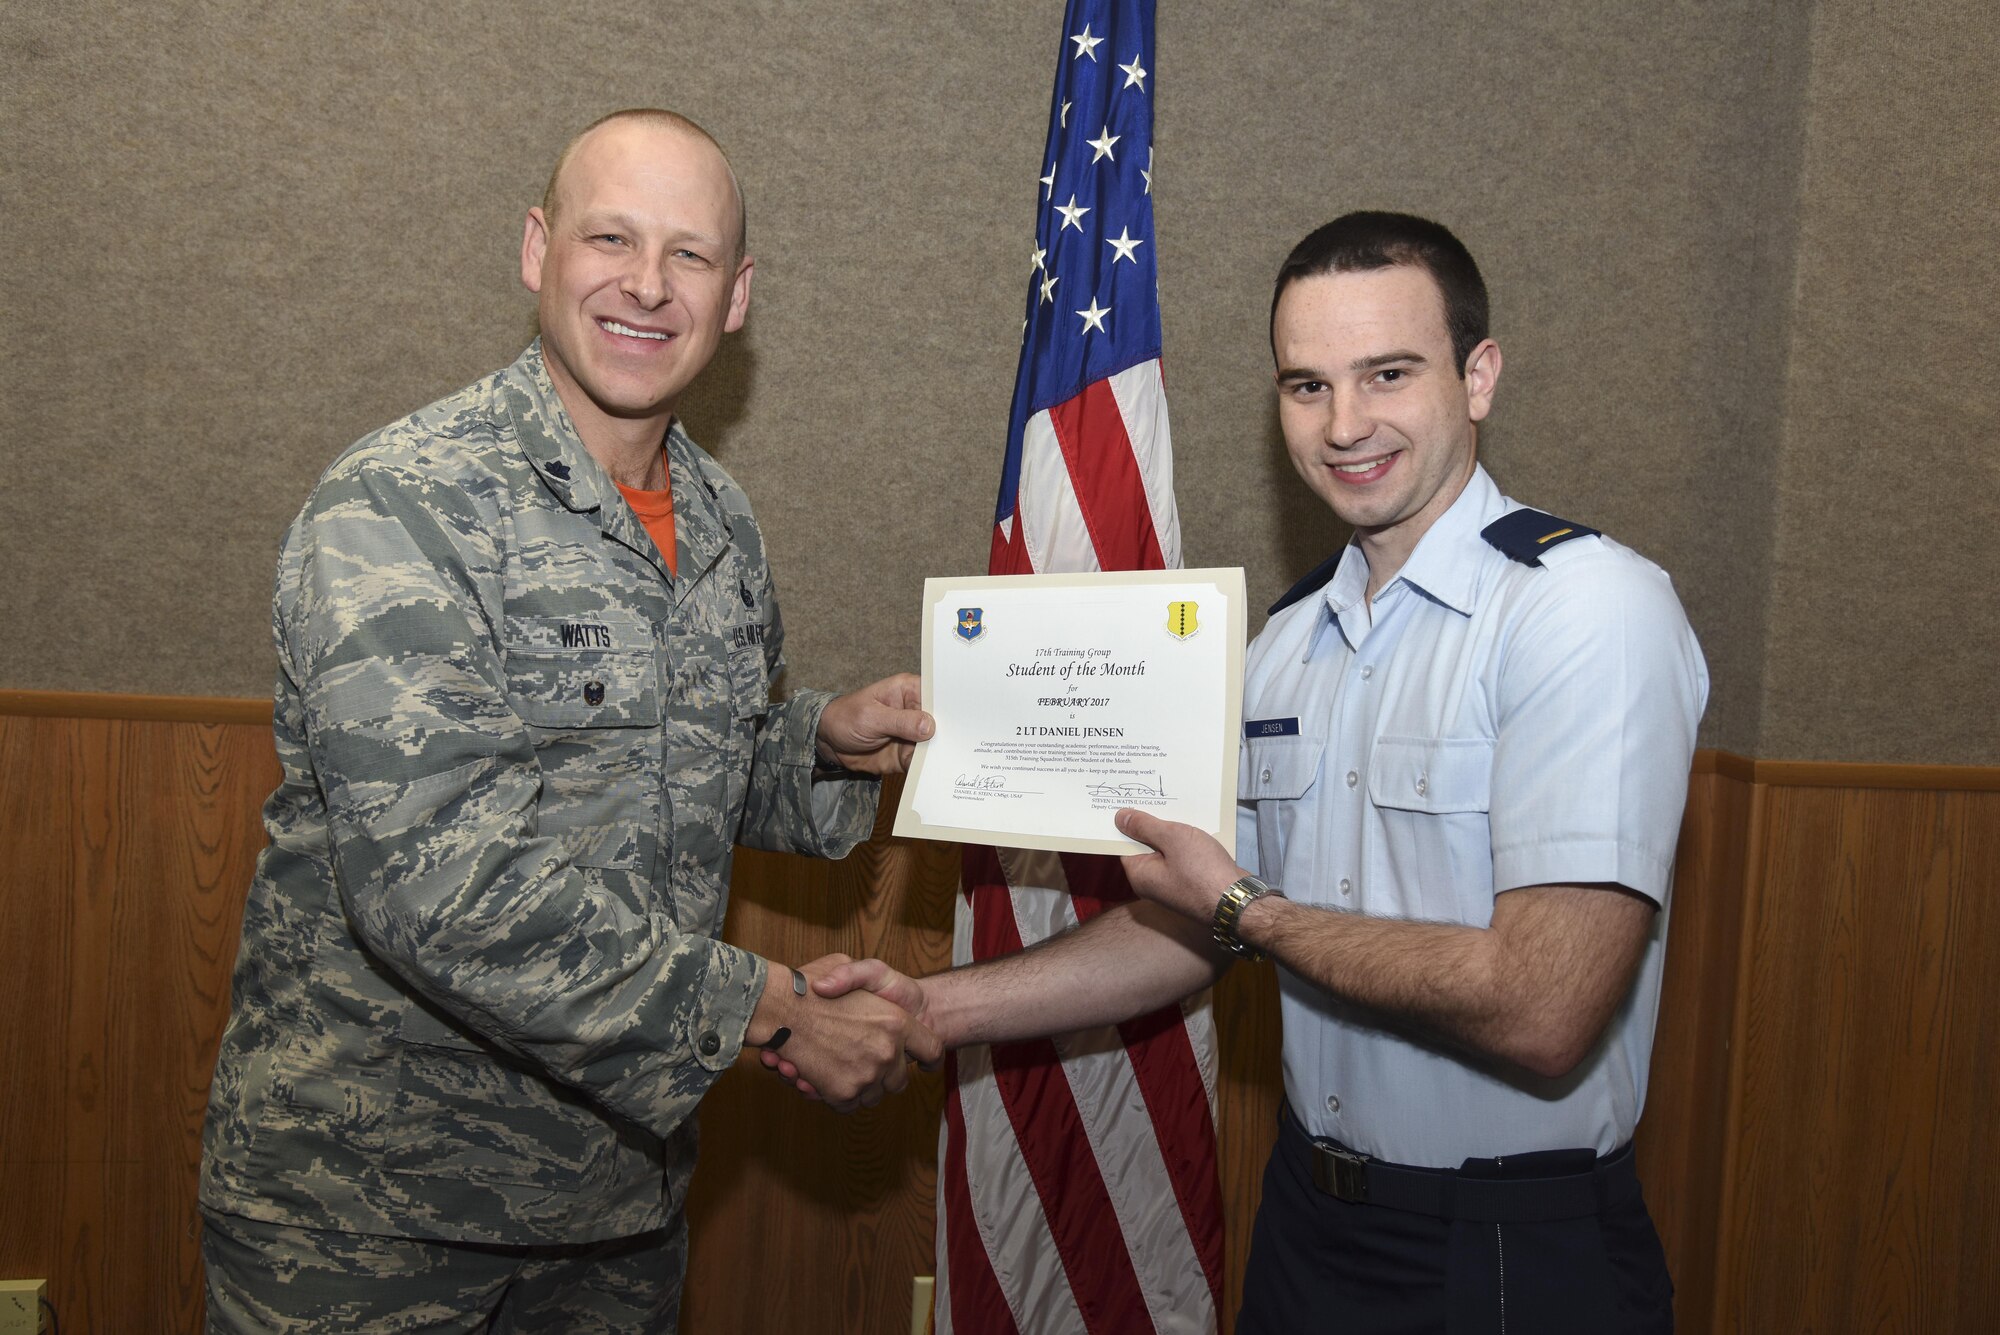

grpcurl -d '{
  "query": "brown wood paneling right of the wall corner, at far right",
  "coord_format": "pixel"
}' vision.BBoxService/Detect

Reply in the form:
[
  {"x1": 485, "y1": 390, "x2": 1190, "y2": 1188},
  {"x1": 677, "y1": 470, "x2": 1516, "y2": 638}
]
[{"x1": 1718, "y1": 787, "x2": 2000, "y2": 1331}]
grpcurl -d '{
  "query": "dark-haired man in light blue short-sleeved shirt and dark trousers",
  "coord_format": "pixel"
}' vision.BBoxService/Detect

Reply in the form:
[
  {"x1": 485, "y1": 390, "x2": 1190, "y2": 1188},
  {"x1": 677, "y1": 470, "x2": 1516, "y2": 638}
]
[{"x1": 808, "y1": 214, "x2": 1708, "y2": 1333}]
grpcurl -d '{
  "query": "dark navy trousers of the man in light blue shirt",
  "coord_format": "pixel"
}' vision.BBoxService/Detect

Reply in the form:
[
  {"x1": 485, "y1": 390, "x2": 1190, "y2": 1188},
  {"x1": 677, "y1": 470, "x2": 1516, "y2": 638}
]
[{"x1": 1236, "y1": 1113, "x2": 1674, "y2": 1335}]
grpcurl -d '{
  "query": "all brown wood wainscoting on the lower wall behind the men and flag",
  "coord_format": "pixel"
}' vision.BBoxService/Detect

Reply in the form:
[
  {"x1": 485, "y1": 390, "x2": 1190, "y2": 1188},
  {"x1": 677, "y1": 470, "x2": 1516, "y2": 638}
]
[{"x1": 0, "y1": 693, "x2": 2000, "y2": 1335}]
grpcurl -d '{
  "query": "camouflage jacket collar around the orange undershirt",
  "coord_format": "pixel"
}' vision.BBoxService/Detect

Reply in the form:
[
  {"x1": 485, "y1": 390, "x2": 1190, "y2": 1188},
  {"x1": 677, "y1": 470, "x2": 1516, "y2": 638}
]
[{"x1": 504, "y1": 338, "x2": 730, "y2": 598}]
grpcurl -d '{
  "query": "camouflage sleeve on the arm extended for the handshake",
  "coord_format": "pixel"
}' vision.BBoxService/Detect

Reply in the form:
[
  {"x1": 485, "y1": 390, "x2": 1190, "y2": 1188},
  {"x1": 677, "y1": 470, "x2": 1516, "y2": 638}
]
[{"x1": 284, "y1": 460, "x2": 764, "y2": 1133}]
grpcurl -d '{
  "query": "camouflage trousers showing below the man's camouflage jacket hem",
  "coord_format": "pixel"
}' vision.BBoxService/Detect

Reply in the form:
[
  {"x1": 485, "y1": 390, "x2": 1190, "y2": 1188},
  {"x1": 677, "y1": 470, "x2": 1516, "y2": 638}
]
[{"x1": 202, "y1": 1209, "x2": 688, "y2": 1335}]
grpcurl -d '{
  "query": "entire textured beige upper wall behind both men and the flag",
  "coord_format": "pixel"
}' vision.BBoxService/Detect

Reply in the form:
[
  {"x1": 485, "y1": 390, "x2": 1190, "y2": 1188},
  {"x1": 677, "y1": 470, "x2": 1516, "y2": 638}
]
[{"x1": 0, "y1": 0, "x2": 2000, "y2": 763}]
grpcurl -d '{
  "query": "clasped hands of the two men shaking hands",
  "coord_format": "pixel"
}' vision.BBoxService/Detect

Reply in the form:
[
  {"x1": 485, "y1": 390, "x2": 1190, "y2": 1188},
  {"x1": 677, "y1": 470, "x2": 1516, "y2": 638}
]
[{"x1": 744, "y1": 955, "x2": 944, "y2": 1113}]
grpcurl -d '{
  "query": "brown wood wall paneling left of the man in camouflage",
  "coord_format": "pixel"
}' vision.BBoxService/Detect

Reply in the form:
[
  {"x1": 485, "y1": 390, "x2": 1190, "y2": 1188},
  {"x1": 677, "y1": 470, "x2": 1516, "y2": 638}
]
[{"x1": 0, "y1": 717, "x2": 276, "y2": 1335}]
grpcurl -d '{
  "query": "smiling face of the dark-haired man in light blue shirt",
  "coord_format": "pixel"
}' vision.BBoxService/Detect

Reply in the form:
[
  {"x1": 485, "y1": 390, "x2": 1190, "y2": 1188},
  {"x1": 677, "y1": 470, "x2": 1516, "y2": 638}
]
[{"x1": 1272, "y1": 264, "x2": 1500, "y2": 590}]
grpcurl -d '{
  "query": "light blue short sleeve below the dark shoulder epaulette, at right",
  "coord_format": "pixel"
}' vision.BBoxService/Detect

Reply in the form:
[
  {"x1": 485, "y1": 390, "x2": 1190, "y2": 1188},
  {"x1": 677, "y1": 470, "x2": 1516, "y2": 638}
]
[{"x1": 1490, "y1": 550, "x2": 1708, "y2": 903}]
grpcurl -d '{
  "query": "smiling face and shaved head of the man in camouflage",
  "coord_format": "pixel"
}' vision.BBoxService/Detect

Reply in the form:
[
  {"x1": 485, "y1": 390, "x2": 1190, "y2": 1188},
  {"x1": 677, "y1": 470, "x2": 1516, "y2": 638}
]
[{"x1": 520, "y1": 118, "x2": 752, "y2": 463}]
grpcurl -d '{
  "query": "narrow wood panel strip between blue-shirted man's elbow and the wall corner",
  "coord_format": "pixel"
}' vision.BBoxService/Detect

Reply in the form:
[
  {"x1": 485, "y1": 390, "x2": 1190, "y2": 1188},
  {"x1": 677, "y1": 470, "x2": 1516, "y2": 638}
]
[{"x1": 1634, "y1": 767, "x2": 1752, "y2": 1335}]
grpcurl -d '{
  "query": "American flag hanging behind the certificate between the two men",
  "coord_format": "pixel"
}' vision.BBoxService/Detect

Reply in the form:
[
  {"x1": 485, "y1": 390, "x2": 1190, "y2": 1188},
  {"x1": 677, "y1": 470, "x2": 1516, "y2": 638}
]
[{"x1": 936, "y1": 0, "x2": 1222, "y2": 1335}]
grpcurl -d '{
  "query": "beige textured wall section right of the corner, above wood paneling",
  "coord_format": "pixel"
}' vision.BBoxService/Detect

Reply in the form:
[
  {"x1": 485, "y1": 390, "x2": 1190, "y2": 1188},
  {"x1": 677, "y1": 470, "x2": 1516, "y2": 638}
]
[{"x1": 1762, "y1": 0, "x2": 2000, "y2": 763}]
